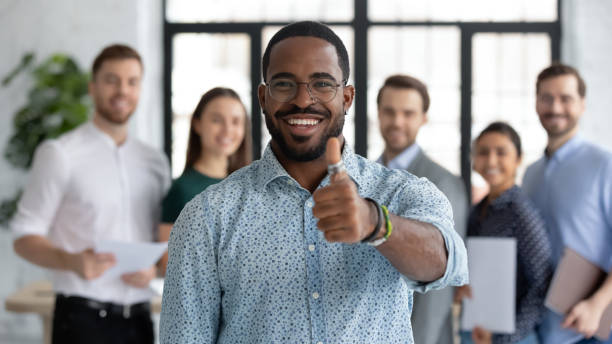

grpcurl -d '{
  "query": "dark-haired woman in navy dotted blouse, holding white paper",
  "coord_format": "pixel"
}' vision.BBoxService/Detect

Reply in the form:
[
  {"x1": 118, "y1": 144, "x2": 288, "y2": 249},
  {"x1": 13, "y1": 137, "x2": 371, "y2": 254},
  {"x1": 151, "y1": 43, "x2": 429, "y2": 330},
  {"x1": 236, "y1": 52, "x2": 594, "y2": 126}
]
[{"x1": 455, "y1": 122, "x2": 553, "y2": 344}]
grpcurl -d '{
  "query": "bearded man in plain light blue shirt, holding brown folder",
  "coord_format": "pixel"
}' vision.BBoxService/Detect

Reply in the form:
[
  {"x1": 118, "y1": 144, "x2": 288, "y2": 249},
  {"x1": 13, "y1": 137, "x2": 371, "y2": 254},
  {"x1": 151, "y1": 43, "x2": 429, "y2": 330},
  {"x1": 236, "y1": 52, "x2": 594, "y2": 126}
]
[{"x1": 523, "y1": 63, "x2": 612, "y2": 344}]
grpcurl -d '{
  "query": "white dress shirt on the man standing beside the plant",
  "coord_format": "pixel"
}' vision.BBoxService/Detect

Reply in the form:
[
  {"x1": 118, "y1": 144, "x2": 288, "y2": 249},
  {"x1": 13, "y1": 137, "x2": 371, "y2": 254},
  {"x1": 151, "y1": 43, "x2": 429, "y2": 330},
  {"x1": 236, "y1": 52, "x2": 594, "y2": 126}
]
[{"x1": 11, "y1": 122, "x2": 170, "y2": 304}]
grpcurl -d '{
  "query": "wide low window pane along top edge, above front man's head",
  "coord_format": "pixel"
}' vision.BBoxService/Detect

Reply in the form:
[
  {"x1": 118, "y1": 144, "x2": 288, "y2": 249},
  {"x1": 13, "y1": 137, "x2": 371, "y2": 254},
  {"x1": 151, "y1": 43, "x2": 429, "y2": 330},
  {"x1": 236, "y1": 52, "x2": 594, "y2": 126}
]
[{"x1": 166, "y1": 0, "x2": 353, "y2": 23}]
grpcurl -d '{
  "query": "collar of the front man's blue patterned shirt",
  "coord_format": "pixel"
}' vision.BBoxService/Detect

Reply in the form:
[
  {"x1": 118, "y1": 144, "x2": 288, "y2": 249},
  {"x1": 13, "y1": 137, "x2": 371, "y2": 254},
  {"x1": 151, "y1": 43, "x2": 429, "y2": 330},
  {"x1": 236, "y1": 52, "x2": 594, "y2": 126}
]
[{"x1": 257, "y1": 140, "x2": 362, "y2": 188}]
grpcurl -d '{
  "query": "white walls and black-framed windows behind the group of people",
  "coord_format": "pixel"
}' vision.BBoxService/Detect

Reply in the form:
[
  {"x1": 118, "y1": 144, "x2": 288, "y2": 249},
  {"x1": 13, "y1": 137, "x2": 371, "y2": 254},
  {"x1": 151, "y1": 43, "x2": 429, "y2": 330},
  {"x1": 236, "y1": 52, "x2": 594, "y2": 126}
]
[{"x1": 0, "y1": 0, "x2": 612, "y2": 343}]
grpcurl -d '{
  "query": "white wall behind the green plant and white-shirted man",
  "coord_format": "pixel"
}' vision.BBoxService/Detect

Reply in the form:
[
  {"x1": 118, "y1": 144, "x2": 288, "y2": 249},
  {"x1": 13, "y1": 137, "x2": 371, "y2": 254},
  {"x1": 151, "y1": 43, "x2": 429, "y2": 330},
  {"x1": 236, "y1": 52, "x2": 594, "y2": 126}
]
[{"x1": 0, "y1": 0, "x2": 163, "y2": 343}]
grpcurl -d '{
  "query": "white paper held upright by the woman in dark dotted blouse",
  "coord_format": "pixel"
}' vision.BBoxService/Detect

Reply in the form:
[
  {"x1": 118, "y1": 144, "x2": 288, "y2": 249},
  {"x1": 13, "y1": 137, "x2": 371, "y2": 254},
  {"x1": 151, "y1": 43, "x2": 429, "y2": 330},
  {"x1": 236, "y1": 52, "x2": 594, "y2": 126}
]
[{"x1": 461, "y1": 237, "x2": 516, "y2": 333}]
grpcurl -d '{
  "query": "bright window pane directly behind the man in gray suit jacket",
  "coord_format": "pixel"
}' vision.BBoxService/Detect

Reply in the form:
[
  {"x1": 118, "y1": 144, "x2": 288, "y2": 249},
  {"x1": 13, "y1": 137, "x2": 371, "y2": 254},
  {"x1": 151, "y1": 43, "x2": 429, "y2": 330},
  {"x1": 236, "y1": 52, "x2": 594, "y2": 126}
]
[{"x1": 368, "y1": 27, "x2": 461, "y2": 175}]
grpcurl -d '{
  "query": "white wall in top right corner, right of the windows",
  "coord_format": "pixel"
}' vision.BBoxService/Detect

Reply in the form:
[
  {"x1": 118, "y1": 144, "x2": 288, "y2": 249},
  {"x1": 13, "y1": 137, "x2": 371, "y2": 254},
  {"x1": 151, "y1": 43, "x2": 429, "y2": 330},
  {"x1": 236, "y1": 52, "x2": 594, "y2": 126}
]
[{"x1": 561, "y1": 0, "x2": 612, "y2": 150}]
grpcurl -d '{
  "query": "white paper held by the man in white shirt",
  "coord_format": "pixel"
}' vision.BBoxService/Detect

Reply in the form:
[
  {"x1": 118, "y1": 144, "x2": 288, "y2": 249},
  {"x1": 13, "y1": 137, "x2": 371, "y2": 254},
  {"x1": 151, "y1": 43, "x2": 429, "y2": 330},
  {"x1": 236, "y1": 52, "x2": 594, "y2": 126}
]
[{"x1": 96, "y1": 241, "x2": 168, "y2": 278}]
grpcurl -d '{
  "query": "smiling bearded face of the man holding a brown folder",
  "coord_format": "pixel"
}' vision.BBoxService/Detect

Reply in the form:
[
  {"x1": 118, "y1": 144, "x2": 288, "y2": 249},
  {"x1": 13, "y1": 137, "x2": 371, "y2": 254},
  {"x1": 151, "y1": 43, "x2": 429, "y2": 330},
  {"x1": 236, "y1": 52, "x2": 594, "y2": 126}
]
[{"x1": 536, "y1": 74, "x2": 584, "y2": 139}]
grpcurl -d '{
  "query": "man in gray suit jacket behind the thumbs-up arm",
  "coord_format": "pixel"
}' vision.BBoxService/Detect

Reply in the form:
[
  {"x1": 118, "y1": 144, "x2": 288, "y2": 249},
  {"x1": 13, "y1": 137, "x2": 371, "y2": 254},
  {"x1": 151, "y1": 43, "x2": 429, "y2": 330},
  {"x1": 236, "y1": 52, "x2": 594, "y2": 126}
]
[{"x1": 377, "y1": 75, "x2": 469, "y2": 344}]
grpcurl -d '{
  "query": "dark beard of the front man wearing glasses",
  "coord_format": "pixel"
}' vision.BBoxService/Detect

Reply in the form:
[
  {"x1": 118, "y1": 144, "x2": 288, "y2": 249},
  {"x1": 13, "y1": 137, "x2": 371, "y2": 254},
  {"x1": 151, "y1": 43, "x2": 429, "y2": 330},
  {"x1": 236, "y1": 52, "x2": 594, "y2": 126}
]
[{"x1": 263, "y1": 106, "x2": 346, "y2": 162}]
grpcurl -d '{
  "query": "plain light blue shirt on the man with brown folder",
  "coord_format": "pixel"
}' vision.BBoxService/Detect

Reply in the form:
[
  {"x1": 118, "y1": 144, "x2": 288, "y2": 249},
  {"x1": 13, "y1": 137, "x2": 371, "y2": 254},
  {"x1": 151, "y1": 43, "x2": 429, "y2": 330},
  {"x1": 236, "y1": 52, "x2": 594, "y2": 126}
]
[{"x1": 523, "y1": 137, "x2": 612, "y2": 344}]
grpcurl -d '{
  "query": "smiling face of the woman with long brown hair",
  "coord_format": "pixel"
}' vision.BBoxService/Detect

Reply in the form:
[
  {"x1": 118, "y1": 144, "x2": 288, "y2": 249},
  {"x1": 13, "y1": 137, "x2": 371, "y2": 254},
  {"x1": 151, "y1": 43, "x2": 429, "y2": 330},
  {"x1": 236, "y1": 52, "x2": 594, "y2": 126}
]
[{"x1": 193, "y1": 97, "x2": 246, "y2": 157}]
